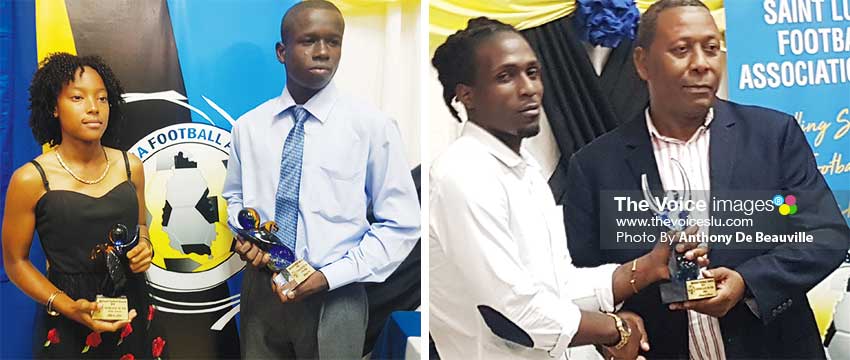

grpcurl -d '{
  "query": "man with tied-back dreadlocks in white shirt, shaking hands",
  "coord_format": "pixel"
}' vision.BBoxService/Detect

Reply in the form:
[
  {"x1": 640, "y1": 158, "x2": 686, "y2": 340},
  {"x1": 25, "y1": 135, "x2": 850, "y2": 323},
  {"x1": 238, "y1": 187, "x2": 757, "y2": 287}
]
[{"x1": 429, "y1": 18, "x2": 707, "y2": 359}]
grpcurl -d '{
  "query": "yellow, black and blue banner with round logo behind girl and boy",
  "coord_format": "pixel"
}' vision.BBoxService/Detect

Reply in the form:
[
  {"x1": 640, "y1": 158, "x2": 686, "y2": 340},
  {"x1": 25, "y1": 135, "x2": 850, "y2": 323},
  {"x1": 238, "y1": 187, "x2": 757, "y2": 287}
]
[{"x1": 2, "y1": 0, "x2": 295, "y2": 358}]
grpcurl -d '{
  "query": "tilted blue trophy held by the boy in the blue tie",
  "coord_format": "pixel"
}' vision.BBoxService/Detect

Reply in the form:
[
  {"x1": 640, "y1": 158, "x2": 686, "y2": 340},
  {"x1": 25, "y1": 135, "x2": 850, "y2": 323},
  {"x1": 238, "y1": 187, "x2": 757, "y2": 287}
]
[{"x1": 230, "y1": 208, "x2": 316, "y2": 294}]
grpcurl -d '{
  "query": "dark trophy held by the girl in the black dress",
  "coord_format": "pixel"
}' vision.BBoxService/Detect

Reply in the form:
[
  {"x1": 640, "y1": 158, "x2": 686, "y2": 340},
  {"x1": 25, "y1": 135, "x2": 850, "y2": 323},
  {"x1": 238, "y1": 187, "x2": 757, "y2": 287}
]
[{"x1": 91, "y1": 224, "x2": 139, "y2": 321}]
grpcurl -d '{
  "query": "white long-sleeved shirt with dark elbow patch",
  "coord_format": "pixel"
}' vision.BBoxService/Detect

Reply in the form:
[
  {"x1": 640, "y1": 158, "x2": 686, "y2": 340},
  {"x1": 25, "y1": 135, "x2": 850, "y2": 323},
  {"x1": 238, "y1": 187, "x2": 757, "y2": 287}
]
[{"x1": 429, "y1": 123, "x2": 617, "y2": 359}]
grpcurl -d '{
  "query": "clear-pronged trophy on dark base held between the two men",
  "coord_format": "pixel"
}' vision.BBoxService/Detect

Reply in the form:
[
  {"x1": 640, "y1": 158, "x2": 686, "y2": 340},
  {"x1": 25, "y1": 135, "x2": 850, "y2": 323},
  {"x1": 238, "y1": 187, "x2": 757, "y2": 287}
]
[{"x1": 641, "y1": 159, "x2": 717, "y2": 304}]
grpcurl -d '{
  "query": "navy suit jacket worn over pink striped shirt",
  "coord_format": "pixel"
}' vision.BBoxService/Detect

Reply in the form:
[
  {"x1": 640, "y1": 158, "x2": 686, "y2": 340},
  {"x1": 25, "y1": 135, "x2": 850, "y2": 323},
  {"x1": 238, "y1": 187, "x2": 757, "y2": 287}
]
[{"x1": 564, "y1": 100, "x2": 850, "y2": 359}]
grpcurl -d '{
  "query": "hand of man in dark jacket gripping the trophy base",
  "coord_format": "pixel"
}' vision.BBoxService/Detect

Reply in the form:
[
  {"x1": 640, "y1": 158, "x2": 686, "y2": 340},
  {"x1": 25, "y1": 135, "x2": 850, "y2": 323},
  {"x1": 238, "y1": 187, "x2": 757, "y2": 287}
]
[{"x1": 670, "y1": 267, "x2": 747, "y2": 318}]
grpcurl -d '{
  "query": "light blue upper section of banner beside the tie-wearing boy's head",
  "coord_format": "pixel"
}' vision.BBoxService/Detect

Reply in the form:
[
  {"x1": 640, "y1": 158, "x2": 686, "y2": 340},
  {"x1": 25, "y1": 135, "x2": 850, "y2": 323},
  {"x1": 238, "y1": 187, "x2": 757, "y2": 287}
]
[{"x1": 168, "y1": 0, "x2": 296, "y2": 130}]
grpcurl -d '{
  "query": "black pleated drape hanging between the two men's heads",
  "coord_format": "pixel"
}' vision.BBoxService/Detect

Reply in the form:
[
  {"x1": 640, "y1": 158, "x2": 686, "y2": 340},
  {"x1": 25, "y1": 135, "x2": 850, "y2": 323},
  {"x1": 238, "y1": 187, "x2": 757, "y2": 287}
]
[{"x1": 522, "y1": 16, "x2": 649, "y2": 204}]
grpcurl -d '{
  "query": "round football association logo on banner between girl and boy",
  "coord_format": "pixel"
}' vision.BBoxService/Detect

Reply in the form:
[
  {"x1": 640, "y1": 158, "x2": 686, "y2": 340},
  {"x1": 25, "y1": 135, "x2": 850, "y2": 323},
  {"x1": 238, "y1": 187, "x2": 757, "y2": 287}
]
[{"x1": 125, "y1": 92, "x2": 245, "y2": 330}]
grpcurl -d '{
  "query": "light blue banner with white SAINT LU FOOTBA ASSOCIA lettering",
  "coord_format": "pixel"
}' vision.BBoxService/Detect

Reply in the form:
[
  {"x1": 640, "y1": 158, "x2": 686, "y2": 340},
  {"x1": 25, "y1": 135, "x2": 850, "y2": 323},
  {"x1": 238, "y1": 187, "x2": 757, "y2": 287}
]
[{"x1": 726, "y1": 0, "x2": 850, "y2": 348}]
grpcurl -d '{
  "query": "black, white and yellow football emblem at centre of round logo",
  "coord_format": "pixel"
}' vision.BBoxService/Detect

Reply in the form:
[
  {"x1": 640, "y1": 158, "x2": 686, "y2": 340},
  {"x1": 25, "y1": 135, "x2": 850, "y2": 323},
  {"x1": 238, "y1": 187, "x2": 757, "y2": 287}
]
[{"x1": 144, "y1": 143, "x2": 232, "y2": 273}]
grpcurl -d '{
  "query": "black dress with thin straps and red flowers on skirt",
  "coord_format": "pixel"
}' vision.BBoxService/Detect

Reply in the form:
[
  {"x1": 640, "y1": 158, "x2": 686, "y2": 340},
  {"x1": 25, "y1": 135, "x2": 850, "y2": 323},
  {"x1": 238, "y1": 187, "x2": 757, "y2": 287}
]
[{"x1": 32, "y1": 153, "x2": 151, "y2": 359}]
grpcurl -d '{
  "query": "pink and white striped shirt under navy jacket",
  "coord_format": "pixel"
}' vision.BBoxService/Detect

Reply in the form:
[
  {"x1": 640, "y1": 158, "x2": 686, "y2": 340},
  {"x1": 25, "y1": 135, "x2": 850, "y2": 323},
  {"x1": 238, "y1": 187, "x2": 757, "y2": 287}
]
[{"x1": 646, "y1": 108, "x2": 726, "y2": 360}]
